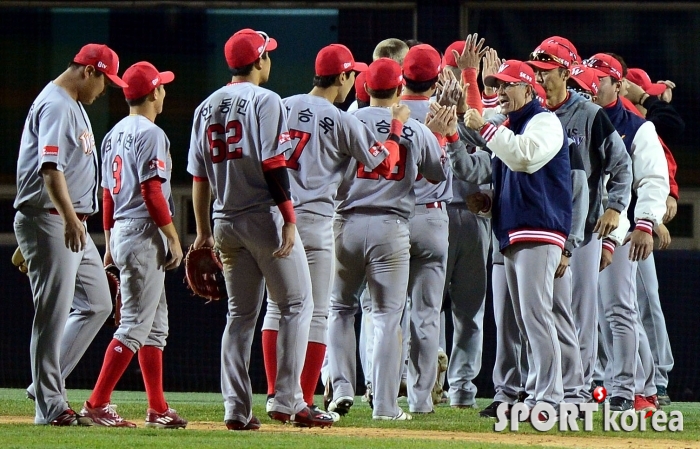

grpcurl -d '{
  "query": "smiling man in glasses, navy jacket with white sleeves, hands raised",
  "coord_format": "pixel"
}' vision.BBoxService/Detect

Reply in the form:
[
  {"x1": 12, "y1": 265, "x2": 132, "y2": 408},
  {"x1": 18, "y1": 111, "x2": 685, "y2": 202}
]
[{"x1": 465, "y1": 60, "x2": 572, "y2": 412}]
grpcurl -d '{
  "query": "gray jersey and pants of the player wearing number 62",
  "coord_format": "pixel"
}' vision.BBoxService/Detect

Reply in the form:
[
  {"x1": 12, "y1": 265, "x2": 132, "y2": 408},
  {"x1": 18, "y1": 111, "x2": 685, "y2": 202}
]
[{"x1": 187, "y1": 82, "x2": 313, "y2": 422}]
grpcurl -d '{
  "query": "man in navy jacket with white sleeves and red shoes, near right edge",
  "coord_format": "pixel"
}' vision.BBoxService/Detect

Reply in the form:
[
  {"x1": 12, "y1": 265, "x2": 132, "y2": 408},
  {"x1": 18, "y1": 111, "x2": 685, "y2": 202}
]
[{"x1": 585, "y1": 53, "x2": 669, "y2": 411}]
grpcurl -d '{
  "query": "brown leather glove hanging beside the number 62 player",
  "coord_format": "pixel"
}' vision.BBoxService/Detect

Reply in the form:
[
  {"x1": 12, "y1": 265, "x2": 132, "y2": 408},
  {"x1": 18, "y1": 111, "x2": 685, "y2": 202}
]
[{"x1": 185, "y1": 246, "x2": 228, "y2": 301}]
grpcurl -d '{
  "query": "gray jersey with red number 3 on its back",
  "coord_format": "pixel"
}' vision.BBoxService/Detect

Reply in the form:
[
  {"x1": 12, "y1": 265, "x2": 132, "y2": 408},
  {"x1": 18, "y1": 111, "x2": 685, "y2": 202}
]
[{"x1": 102, "y1": 115, "x2": 175, "y2": 220}]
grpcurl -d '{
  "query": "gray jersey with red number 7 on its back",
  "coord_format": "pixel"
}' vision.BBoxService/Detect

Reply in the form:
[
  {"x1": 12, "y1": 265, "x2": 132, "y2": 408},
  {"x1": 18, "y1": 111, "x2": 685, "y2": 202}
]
[{"x1": 283, "y1": 94, "x2": 386, "y2": 217}]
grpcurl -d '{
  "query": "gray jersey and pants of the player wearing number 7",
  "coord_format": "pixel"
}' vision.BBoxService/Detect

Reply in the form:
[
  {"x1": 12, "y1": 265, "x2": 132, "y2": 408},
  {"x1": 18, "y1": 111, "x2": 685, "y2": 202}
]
[{"x1": 263, "y1": 94, "x2": 389, "y2": 344}]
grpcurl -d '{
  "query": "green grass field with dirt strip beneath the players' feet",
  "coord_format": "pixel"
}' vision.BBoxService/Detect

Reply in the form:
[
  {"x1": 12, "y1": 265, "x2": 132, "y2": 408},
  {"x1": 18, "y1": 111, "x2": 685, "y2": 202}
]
[{"x1": 0, "y1": 389, "x2": 700, "y2": 449}]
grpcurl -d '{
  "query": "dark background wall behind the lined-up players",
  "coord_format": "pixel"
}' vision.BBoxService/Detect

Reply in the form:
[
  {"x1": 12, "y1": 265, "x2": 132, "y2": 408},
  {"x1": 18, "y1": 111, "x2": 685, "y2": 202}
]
[{"x1": 0, "y1": 1, "x2": 700, "y2": 400}]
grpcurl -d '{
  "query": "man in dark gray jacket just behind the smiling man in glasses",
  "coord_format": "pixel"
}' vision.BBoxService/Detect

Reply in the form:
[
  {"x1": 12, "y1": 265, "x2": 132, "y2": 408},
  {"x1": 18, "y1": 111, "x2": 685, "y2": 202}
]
[{"x1": 528, "y1": 36, "x2": 632, "y2": 400}]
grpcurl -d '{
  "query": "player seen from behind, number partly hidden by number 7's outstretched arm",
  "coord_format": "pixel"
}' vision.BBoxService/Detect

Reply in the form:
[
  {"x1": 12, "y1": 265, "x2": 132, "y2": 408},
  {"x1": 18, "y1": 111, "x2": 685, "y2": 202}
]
[{"x1": 328, "y1": 58, "x2": 445, "y2": 420}]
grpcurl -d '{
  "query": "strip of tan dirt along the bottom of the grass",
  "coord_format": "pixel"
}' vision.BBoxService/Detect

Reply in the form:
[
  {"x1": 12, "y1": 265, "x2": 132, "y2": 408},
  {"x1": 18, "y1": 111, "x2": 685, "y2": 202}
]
[{"x1": 0, "y1": 416, "x2": 700, "y2": 449}]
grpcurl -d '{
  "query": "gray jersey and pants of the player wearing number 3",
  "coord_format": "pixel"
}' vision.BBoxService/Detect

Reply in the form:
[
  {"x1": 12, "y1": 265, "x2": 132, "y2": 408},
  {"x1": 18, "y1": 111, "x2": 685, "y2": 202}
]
[{"x1": 102, "y1": 115, "x2": 174, "y2": 352}]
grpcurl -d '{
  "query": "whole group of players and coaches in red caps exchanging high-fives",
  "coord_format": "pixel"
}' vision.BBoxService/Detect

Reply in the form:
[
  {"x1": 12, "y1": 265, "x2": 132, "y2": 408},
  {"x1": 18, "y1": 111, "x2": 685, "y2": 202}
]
[{"x1": 15, "y1": 29, "x2": 682, "y2": 430}]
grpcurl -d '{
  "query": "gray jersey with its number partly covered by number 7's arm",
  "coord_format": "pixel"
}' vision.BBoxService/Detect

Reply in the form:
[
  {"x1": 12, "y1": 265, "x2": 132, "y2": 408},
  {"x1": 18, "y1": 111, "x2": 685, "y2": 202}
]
[{"x1": 337, "y1": 107, "x2": 445, "y2": 218}]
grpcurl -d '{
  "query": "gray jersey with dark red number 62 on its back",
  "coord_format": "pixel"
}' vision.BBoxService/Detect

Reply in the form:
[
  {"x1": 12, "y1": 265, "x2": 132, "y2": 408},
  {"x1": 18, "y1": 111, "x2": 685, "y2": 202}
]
[{"x1": 187, "y1": 82, "x2": 291, "y2": 218}]
